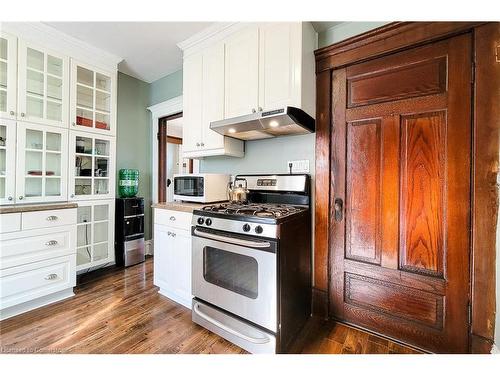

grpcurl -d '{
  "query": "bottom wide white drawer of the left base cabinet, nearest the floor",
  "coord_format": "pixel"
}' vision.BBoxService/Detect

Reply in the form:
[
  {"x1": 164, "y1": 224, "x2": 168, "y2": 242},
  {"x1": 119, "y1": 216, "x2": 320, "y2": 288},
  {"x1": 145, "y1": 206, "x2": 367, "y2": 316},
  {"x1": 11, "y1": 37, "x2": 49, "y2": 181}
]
[{"x1": 0, "y1": 254, "x2": 76, "y2": 309}]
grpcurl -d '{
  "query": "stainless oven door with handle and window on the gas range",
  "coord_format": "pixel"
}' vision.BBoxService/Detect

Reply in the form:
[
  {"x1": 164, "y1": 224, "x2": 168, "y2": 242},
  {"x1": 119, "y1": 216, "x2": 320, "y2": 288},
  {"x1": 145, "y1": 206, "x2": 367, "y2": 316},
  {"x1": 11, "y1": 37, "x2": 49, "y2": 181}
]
[{"x1": 192, "y1": 228, "x2": 277, "y2": 332}]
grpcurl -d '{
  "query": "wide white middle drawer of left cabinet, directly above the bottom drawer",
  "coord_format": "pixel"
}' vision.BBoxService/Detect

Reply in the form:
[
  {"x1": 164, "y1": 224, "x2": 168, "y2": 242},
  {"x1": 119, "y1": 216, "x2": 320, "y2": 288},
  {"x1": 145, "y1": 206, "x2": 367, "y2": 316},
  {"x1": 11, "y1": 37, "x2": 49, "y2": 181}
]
[{"x1": 0, "y1": 225, "x2": 76, "y2": 269}]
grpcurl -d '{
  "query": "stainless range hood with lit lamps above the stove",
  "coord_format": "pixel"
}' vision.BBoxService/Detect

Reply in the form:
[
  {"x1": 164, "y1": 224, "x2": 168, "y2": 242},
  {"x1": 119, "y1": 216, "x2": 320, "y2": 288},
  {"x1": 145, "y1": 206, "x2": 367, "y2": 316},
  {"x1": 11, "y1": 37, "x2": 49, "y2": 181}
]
[{"x1": 210, "y1": 107, "x2": 315, "y2": 141}]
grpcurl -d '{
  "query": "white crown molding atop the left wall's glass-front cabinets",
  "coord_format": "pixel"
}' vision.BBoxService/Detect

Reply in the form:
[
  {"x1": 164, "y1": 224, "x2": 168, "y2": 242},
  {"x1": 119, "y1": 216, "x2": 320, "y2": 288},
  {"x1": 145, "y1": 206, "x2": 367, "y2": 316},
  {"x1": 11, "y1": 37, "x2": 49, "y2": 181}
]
[{"x1": 0, "y1": 22, "x2": 123, "y2": 71}]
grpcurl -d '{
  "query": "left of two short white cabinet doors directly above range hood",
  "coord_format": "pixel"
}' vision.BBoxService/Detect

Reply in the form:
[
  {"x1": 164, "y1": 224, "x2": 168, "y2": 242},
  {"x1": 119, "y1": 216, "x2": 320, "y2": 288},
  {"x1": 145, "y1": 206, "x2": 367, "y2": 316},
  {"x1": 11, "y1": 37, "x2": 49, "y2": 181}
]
[{"x1": 224, "y1": 26, "x2": 259, "y2": 118}]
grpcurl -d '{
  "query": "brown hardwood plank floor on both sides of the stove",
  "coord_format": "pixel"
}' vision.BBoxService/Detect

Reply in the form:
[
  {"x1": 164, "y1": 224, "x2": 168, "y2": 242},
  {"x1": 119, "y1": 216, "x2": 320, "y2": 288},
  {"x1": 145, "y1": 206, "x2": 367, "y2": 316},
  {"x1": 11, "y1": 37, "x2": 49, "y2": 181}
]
[{"x1": 0, "y1": 259, "x2": 422, "y2": 354}]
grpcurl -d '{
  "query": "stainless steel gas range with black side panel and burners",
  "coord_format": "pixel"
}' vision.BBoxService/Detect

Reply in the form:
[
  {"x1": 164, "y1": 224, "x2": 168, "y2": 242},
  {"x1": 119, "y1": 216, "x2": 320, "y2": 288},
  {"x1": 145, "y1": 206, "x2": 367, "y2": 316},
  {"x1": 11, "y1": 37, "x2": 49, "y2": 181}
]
[{"x1": 192, "y1": 175, "x2": 311, "y2": 353}]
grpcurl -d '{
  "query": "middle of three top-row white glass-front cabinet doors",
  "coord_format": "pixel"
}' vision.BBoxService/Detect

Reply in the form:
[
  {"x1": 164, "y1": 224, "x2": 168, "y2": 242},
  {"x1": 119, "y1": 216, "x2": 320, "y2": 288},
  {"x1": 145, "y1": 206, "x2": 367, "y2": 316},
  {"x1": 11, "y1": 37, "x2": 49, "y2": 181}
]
[{"x1": 17, "y1": 40, "x2": 69, "y2": 127}]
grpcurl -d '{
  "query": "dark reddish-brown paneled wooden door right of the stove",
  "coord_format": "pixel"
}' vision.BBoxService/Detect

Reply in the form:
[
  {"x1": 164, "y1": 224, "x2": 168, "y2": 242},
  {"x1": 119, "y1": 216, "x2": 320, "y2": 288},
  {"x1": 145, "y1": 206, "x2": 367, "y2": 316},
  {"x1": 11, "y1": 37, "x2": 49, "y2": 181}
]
[{"x1": 330, "y1": 34, "x2": 472, "y2": 352}]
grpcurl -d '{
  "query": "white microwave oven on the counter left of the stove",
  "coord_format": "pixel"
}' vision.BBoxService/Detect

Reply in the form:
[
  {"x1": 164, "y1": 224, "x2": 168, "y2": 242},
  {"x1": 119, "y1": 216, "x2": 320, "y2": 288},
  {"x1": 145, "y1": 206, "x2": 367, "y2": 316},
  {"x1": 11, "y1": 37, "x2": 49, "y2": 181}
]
[{"x1": 174, "y1": 173, "x2": 231, "y2": 203}]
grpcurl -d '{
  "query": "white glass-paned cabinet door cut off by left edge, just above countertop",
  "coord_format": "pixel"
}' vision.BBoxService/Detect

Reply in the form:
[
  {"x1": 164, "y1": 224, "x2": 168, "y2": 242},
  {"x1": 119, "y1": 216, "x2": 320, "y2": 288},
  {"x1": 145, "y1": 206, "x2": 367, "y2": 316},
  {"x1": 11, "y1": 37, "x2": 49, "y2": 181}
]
[{"x1": 0, "y1": 119, "x2": 16, "y2": 204}]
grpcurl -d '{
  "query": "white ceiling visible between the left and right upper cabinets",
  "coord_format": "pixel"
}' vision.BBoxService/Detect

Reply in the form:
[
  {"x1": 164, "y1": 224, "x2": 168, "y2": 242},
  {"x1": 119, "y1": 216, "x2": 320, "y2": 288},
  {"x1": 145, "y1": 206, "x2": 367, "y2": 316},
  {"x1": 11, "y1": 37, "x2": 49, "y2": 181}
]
[{"x1": 45, "y1": 22, "x2": 212, "y2": 83}]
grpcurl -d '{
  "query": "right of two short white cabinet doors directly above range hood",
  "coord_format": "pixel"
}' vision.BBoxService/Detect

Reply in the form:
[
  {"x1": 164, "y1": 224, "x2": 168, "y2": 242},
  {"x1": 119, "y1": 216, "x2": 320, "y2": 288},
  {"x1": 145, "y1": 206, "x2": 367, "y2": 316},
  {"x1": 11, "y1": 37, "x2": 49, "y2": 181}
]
[{"x1": 259, "y1": 22, "x2": 301, "y2": 111}]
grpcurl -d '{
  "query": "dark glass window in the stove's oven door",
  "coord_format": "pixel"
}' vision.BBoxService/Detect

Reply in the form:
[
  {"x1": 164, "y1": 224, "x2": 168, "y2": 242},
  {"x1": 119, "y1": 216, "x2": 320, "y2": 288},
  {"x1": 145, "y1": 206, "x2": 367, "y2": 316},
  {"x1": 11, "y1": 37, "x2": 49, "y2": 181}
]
[{"x1": 203, "y1": 246, "x2": 259, "y2": 299}]
